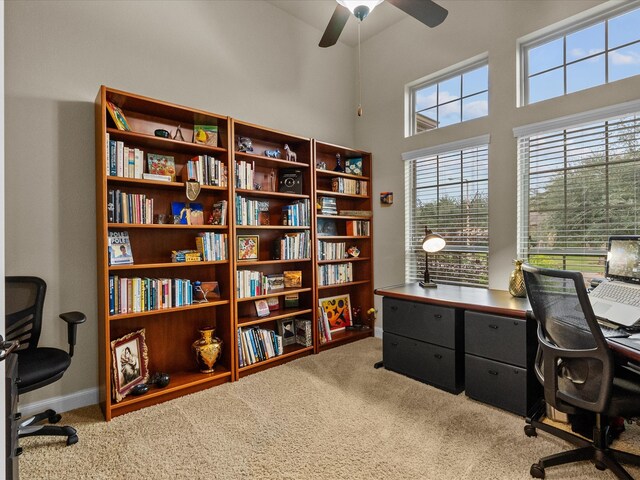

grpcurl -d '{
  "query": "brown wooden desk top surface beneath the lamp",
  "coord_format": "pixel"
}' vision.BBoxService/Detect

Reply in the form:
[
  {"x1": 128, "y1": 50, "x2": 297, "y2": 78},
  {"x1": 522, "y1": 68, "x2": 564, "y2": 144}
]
[{"x1": 375, "y1": 283, "x2": 530, "y2": 318}]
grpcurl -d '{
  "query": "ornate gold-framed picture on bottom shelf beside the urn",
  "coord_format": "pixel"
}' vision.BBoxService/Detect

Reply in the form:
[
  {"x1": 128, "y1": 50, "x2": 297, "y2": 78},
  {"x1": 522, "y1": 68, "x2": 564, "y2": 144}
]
[{"x1": 111, "y1": 328, "x2": 149, "y2": 402}]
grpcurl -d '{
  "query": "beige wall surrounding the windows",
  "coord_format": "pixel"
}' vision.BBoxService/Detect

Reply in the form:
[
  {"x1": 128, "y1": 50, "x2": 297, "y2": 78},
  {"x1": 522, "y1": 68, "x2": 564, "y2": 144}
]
[{"x1": 356, "y1": 0, "x2": 640, "y2": 322}]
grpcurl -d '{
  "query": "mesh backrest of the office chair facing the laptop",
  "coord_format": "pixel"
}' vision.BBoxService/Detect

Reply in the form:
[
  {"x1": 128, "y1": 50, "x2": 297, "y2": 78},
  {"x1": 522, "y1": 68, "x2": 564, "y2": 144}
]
[{"x1": 522, "y1": 264, "x2": 614, "y2": 413}]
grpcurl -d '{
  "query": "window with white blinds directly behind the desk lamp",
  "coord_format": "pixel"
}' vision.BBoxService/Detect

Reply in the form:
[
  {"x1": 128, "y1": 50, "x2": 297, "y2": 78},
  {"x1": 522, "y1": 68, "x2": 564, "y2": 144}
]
[{"x1": 403, "y1": 135, "x2": 489, "y2": 287}]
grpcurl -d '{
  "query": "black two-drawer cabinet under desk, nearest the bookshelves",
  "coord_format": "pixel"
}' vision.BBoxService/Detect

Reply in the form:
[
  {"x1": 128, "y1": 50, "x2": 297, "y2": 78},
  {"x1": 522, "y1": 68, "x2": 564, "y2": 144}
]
[{"x1": 382, "y1": 297, "x2": 464, "y2": 393}]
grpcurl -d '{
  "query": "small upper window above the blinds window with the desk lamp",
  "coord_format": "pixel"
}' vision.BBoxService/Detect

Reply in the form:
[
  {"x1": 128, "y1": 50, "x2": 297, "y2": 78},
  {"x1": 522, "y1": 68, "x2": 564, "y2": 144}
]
[{"x1": 407, "y1": 56, "x2": 489, "y2": 135}]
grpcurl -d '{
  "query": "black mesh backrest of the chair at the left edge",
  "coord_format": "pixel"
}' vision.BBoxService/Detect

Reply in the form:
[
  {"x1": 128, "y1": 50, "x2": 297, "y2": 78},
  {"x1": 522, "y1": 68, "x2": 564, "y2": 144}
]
[{"x1": 5, "y1": 277, "x2": 47, "y2": 351}]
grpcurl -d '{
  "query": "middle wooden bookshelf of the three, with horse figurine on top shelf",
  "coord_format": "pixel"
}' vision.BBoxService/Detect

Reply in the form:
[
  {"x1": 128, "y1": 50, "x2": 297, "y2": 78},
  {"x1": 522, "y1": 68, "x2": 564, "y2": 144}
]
[{"x1": 231, "y1": 120, "x2": 316, "y2": 378}]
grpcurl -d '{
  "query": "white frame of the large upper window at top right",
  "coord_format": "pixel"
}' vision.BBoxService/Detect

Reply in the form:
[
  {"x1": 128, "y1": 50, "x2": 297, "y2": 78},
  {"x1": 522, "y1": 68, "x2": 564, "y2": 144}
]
[{"x1": 517, "y1": 0, "x2": 640, "y2": 107}]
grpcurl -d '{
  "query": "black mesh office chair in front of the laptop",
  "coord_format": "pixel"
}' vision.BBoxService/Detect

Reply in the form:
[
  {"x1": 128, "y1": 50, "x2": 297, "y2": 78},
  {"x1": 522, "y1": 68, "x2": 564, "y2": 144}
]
[{"x1": 522, "y1": 264, "x2": 640, "y2": 479}]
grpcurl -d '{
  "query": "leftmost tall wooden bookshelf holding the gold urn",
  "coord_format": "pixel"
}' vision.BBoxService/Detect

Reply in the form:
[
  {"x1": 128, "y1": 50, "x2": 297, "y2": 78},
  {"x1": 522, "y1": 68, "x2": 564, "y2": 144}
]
[{"x1": 95, "y1": 86, "x2": 235, "y2": 420}]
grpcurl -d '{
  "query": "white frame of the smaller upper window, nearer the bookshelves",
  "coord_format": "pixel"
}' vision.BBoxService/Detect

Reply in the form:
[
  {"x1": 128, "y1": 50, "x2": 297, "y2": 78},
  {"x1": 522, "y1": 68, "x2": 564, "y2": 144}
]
[{"x1": 405, "y1": 52, "x2": 490, "y2": 137}]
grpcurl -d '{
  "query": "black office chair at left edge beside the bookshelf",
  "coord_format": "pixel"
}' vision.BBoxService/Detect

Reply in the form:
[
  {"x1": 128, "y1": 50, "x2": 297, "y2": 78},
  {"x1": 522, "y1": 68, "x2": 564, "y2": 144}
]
[{"x1": 5, "y1": 277, "x2": 86, "y2": 445}]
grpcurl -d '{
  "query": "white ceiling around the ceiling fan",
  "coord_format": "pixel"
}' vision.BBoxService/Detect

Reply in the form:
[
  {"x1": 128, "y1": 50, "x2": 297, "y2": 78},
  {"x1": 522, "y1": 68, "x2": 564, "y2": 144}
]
[{"x1": 269, "y1": 0, "x2": 407, "y2": 47}]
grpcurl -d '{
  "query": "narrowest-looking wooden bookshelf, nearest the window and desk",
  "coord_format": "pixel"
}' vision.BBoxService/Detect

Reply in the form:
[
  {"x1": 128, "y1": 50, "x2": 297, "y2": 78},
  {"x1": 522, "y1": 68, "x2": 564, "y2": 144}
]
[{"x1": 313, "y1": 140, "x2": 374, "y2": 351}]
